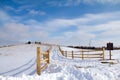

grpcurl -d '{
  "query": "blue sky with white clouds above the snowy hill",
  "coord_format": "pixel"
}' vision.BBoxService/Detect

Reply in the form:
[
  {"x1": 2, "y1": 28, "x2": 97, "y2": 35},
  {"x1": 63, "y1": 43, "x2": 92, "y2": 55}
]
[{"x1": 0, "y1": 0, "x2": 120, "y2": 46}]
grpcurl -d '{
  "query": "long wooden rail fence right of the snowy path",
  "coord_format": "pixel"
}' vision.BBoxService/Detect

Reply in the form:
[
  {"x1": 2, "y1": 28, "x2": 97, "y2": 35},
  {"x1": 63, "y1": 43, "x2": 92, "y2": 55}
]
[{"x1": 59, "y1": 47, "x2": 105, "y2": 60}]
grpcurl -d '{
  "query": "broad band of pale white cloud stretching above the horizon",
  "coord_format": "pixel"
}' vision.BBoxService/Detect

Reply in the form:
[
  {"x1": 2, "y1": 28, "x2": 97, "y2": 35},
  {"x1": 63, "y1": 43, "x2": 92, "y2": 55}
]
[{"x1": 0, "y1": 9, "x2": 120, "y2": 45}]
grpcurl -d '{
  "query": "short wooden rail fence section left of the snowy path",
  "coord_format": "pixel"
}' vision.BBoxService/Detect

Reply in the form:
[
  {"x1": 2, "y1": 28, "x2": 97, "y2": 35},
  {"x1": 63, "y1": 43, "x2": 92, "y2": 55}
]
[{"x1": 36, "y1": 47, "x2": 52, "y2": 75}]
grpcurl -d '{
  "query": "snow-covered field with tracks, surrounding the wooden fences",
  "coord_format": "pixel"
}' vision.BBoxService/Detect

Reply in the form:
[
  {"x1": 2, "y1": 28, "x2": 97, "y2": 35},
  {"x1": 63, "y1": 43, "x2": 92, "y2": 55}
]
[{"x1": 0, "y1": 44, "x2": 120, "y2": 80}]
